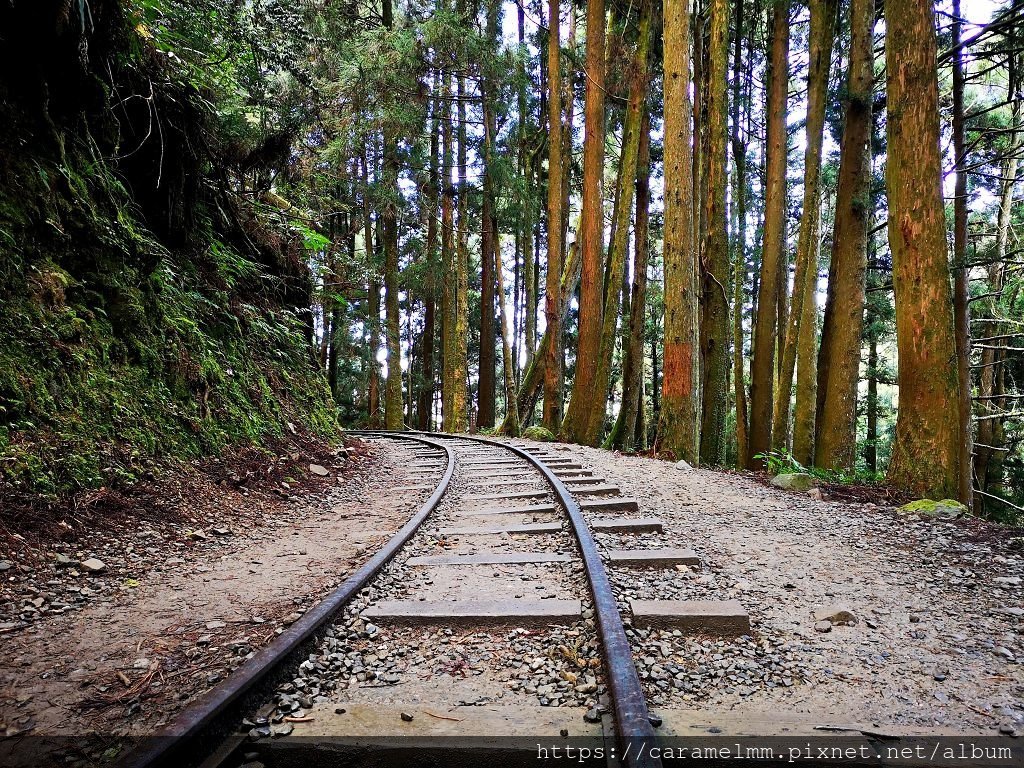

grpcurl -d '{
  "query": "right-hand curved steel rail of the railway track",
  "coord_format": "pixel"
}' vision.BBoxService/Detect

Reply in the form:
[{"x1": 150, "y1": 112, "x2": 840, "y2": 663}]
[{"x1": 374, "y1": 431, "x2": 662, "y2": 768}]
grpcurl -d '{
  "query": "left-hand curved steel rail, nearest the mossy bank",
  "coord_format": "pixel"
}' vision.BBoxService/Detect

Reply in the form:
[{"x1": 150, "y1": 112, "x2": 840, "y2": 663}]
[{"x1": 120, "y1": 433, "x2": 455, "y2": 768}]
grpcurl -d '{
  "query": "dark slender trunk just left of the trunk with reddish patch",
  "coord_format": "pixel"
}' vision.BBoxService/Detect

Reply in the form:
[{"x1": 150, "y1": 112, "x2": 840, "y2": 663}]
[{"x1": 605, "y1": 106, "x2": 650, "y2": 451}]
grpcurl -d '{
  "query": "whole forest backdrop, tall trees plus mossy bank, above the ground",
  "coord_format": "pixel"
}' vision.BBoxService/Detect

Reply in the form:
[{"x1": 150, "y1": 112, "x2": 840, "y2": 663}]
[{"x1": 0, "y1": 0, "x2": 1024, "y2": 519}]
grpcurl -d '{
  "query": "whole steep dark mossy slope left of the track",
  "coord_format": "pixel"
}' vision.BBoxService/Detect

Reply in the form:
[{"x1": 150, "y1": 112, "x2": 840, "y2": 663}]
[{"x1": 0, "y1": 2, "x2": 335, "y2": 498}]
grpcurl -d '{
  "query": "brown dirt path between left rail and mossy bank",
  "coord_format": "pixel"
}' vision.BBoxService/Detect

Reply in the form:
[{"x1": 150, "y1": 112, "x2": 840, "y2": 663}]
[{"x1": 0, "y1": 438, "x2": 428, "y2": 763}]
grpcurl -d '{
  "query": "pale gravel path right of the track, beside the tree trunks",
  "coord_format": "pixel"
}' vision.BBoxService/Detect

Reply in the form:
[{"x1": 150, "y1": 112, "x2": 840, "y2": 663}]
[{"x1": 507, "y1": 438, "x2": 1024, "y2": 732}]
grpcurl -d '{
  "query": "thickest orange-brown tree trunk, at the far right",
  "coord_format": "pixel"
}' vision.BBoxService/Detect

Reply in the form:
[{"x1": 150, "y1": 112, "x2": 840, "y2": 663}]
[{"x1": 886, "y1": 0, "x2": 964, "y2": 499}]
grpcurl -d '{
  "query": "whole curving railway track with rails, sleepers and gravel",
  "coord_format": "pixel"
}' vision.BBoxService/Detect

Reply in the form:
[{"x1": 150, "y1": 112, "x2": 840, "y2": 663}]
[{"x1": 123, "y1": 432, "x2": 746, "y2": 768}]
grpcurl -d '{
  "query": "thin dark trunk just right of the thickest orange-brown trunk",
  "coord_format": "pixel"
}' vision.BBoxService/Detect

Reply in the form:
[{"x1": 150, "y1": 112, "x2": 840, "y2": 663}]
[{"x1": 952, "y1": 0, "x2": 974, "y2": 510}]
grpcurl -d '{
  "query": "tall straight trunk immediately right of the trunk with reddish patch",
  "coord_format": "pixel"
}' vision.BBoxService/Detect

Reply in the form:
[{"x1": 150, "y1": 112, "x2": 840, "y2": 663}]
[{"x1": 700, "y1": 0, "x2": 730, "y2": 466}]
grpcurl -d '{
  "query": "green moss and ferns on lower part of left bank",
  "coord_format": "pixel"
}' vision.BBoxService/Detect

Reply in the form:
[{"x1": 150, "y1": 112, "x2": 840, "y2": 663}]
[{"x1": 0, "y1": 116, "x2": 336, "y2": 497}]
